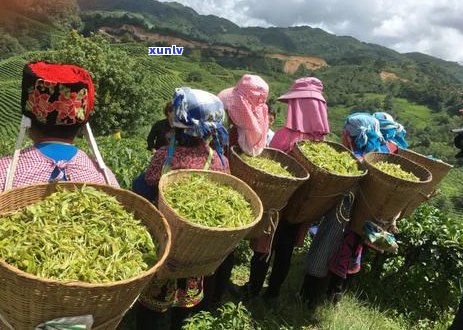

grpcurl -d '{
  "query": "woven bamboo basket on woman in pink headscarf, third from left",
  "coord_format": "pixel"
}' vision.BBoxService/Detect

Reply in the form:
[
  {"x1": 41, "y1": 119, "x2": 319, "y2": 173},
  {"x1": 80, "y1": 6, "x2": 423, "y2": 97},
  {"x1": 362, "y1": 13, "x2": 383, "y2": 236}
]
[{"x1": 230, "y1": 146, "x2": 309, "y2": 238}]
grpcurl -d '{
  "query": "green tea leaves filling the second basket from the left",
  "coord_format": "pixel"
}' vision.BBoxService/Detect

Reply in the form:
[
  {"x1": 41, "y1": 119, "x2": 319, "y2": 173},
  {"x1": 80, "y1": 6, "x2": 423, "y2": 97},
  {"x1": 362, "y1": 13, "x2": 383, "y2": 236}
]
[{"x1": 164, "y1": 174, "x2": 254, "y2": 228}]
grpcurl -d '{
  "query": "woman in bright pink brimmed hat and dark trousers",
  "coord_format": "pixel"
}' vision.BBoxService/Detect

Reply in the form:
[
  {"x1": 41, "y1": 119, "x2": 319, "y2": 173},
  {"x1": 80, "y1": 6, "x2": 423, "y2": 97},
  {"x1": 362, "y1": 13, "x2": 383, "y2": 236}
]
[{"x1": 245, "y1": 77, "x2": 330, "y2": 299}]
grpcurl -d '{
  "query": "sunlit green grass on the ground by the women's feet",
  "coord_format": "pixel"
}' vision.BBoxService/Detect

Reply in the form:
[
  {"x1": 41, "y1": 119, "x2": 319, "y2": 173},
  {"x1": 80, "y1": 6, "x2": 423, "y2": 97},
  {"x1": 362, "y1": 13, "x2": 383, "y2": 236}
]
[{"x1": 114, "y1": 241, "x2": 430, "y2": 330}]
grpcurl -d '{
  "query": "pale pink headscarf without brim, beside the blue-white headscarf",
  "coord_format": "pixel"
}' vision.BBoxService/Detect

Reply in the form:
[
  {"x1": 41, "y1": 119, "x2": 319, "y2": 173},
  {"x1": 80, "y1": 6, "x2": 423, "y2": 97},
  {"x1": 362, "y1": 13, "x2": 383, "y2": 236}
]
[{"x1": 218, "y1": 74, "x2": 269, "y2": 156}]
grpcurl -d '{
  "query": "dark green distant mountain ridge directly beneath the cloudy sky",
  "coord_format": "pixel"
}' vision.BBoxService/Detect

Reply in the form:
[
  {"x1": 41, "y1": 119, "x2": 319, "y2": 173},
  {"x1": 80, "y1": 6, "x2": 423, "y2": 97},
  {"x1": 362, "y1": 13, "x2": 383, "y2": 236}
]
[{"x1": 77, "y1": 0, "x2": 463, "y2": 84}]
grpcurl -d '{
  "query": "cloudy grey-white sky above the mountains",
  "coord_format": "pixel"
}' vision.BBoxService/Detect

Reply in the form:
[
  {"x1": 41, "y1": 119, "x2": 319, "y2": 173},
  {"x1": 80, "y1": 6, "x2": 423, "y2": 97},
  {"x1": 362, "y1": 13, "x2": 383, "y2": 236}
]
[{"x1": 161, "y1": 0, "x2": 463, "y2": 65}]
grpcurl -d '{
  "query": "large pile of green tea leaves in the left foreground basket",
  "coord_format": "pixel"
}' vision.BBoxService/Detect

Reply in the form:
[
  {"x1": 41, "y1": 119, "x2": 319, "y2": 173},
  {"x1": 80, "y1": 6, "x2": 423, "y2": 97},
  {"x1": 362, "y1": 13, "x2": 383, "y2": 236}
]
[{"x1": 0, "y1": 186, "x2": 157, "y2": 283}]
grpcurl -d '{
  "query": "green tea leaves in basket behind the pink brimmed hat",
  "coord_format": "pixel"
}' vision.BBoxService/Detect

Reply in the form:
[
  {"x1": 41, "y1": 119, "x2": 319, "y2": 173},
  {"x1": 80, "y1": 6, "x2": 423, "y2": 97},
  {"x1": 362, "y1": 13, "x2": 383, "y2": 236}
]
[{"x1": 299, "y1": 141, "x2": 364, "y2": 176}]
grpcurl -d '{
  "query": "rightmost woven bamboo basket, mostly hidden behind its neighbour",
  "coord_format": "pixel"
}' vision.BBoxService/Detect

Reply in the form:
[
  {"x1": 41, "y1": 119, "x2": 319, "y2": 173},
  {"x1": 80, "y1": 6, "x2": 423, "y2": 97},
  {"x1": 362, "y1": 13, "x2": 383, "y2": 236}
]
[{"x1": 398, "y1": 149, "x2": 453, "y2": 218}]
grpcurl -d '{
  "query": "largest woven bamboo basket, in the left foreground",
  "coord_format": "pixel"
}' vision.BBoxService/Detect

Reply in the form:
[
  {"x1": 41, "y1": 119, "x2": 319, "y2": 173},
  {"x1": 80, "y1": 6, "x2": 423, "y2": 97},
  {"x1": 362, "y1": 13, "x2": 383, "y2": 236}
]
[{"x1": 0, "y1": 182, "x2": 171, "y2": 330}]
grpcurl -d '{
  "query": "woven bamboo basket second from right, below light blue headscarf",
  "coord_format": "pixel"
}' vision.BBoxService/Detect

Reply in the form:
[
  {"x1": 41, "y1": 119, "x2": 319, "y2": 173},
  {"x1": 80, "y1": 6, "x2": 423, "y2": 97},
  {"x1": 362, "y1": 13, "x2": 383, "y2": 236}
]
[{"x1": 351, "y1": 152, "x2": 432, "y2": 235}]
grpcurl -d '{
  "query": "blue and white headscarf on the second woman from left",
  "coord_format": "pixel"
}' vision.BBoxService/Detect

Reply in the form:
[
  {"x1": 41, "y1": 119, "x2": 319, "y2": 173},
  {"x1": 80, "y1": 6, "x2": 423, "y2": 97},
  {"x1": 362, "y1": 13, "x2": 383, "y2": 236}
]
[{"x1": 172, "y1": 87, "x2": 228, "y2": 164}]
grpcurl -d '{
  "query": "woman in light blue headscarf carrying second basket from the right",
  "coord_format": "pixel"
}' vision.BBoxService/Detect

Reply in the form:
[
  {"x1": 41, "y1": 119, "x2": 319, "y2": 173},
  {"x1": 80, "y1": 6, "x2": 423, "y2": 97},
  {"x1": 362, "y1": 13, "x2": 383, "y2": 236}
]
[{"x1": 300, "y1": 113, "x2": 404, "y2": 308}]
